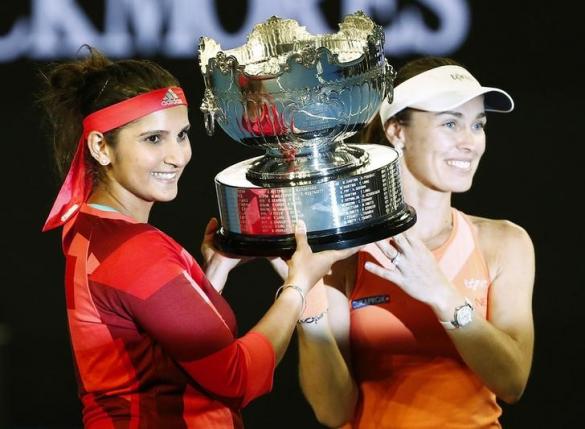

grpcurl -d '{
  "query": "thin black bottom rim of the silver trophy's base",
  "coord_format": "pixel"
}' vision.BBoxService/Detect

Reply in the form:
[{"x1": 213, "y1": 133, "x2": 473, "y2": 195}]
[{"x1": 214, "y1": 206, "x2": 416, "y2": 257}]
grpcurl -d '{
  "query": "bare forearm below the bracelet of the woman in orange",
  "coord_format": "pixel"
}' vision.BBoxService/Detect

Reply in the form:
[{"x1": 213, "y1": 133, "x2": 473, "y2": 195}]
[{"x1": 297, "y1": 313, "x2": 358, "y2": 427}]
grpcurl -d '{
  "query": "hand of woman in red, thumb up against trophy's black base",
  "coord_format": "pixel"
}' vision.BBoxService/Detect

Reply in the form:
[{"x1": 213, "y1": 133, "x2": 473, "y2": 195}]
[{"x1": 285, "y1": 221, "x2": 361, "y2": 293}]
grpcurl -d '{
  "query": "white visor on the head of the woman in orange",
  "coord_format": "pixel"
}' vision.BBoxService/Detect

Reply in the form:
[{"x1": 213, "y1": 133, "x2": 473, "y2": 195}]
[{"x1": 380, "y1": 66, "x2": 514, "y2": 125}]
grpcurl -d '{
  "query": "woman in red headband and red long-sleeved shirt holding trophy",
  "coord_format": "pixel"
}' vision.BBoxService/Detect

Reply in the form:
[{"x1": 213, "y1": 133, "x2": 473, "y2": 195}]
[{"x1": 42, "y1": 48, "x2": 352, "y2": 429}]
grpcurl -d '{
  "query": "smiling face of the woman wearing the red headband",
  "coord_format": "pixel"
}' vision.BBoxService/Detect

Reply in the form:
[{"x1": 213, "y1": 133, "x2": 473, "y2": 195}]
[{"x1": 92, "y1": 106, "x2": 191, "y2": 217}]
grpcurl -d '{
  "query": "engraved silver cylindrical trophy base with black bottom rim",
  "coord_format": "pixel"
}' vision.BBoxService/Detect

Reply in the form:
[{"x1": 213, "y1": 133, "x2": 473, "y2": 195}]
[{"x1": 215, "y1": 144, "x2": 416, "y2": 256}]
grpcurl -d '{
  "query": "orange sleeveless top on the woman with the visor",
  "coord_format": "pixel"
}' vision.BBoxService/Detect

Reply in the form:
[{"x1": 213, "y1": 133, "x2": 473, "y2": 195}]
[{"x1": 345, "y1": 209, "x2": 501, "y2": 429}]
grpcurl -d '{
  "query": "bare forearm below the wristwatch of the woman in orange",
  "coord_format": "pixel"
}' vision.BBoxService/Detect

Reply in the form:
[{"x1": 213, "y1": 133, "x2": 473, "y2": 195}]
[{"x1": 448, "y1": 316, "x2": 532, "y2": 403}]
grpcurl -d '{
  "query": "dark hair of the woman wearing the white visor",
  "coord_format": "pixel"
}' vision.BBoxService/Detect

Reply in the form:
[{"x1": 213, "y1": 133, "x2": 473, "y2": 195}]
[{"x1": 352, "y1": 56, "x2": 461, "y2": 144}]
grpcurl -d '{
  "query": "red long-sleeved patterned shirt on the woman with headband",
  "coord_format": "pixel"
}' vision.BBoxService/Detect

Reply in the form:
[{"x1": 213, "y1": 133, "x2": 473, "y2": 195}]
[{"x1": 63, "y1": 204, "x2": 276, "y2": 429}]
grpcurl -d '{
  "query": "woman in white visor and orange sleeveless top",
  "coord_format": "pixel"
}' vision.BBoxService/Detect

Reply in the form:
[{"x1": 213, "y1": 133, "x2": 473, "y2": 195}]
[{"x1": 272, "y1": 57, "x2": 534, "y2": 429}]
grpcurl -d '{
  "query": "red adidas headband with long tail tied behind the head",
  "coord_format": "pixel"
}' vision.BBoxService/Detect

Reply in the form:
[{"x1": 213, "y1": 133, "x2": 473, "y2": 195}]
[{"x1": 43, "y1": 86, "x2": 187, "y2": 232}]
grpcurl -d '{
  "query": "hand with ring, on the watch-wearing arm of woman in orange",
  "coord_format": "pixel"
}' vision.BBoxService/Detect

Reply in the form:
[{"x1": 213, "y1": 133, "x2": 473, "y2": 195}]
[{"x1": 365, "y1": 232, "x2": 461, "y2": 311}]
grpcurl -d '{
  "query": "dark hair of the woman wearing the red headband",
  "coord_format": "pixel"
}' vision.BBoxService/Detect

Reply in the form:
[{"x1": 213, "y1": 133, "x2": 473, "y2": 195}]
[{"x1": 38, "y1": 45, "x2": 179, "y2": 184}]
